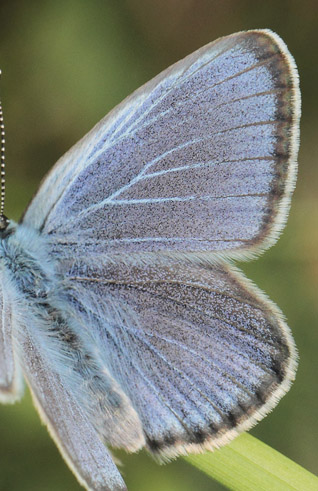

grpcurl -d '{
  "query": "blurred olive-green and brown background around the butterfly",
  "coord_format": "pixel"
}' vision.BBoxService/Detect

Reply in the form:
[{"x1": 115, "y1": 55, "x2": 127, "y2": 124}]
[{"x1": 0, "y1": 0, "x2": 318, "y2": 491}]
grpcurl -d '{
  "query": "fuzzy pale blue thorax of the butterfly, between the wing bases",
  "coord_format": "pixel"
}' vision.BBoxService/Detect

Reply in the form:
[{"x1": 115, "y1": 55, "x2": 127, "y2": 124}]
[{"x1": 0, "y1": 223, "x2": 99, "y2": 358}]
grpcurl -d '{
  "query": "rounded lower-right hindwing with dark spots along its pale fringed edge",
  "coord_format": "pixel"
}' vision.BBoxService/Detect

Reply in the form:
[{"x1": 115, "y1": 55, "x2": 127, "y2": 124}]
[{"x1": 63, "y1": 257, "x2": 295, "y2": 457}]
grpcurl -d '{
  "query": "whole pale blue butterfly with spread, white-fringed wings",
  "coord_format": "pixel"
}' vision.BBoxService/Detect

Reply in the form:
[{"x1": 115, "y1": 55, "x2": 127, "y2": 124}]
[{"x1": 0, "y1": 30, "x2": 300, "y2": 490}]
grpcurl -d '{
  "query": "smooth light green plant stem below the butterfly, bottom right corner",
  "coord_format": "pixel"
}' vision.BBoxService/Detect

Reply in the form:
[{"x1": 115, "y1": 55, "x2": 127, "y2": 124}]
[{"x1": 185, "y1": 433, "x2": 318, "y2": 491}]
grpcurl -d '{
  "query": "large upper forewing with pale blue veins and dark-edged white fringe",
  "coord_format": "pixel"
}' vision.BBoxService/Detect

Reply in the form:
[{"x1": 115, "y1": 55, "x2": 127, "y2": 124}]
[{"x1": 24, "y1": 31, "x2": 300, "y2": 262}]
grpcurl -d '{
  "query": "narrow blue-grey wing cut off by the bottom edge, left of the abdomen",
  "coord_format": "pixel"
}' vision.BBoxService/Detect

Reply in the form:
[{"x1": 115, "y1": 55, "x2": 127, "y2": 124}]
[{"x1": 19, "y1": 327, "x2": 127, "y2": 491}]
